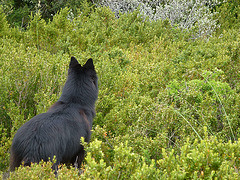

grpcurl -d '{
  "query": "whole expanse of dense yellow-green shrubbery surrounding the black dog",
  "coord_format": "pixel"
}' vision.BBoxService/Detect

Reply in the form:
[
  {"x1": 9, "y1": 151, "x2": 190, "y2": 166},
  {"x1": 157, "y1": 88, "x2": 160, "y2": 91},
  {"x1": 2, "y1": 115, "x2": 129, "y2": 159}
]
[{"x1": 0, "y1": 1, "x2": 240, "y2": 179}]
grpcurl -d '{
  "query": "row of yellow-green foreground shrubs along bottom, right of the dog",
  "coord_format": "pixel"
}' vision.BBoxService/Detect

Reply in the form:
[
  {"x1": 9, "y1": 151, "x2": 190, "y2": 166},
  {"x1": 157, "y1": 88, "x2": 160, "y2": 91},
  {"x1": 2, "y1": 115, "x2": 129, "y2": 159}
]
[{"x1": 81, "y1": 133, "x2": 240, "y2": 179}]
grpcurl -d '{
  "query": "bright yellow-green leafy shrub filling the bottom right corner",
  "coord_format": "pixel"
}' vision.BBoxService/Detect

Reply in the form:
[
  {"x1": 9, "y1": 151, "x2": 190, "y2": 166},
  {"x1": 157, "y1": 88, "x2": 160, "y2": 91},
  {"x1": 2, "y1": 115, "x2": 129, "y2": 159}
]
[{"x1": 157, "y1": 134, "x2": 239, "y2": 179}]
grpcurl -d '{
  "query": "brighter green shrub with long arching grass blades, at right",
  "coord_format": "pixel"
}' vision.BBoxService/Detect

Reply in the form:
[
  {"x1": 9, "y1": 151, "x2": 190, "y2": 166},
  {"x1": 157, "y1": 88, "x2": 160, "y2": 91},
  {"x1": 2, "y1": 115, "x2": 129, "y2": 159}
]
[{"x1": 159, "y1": 72, "x2": 239, "y2": 140}]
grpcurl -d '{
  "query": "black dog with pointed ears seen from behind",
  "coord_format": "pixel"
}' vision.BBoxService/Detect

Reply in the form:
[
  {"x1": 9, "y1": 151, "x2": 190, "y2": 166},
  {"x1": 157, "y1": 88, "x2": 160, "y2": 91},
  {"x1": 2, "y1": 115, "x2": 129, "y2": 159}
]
[{"x1": 10, "y1": 57, "x2": 98, "y2": 173}]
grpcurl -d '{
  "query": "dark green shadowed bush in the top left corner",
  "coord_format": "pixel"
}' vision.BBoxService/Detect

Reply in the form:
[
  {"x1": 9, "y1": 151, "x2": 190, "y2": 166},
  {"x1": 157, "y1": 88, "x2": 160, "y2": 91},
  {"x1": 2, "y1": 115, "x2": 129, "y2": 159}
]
[{"x1": 0, "y1": 0, "x2": 92, "y2": 28}]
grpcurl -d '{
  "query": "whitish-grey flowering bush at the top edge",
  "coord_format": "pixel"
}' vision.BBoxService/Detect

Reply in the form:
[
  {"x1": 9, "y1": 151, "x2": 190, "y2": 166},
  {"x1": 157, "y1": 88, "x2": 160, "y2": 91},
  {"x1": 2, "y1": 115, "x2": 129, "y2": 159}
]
[{"x1": 94, "y1": 0, "x2": 219, "y2": 37}]
